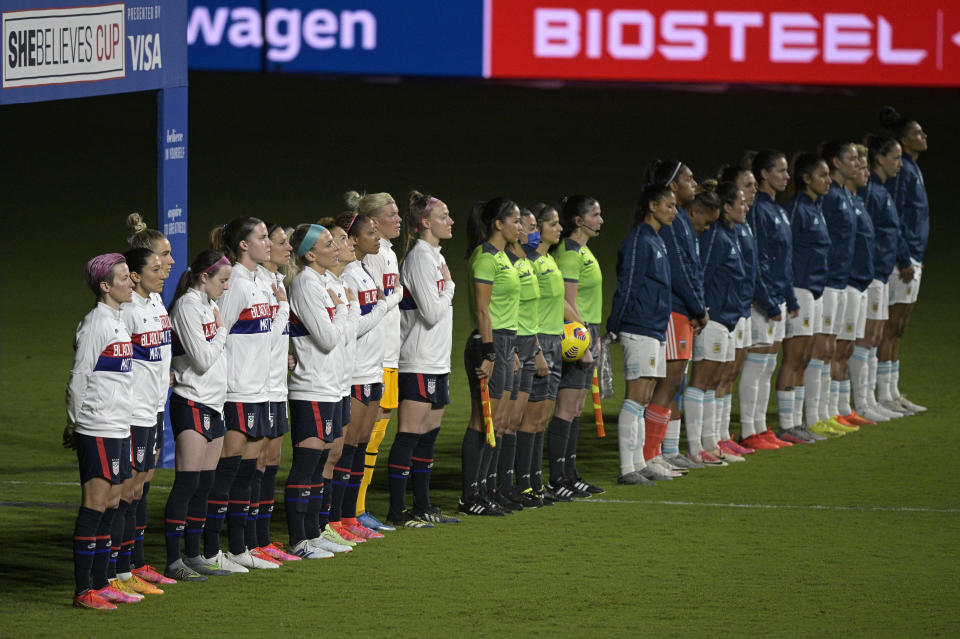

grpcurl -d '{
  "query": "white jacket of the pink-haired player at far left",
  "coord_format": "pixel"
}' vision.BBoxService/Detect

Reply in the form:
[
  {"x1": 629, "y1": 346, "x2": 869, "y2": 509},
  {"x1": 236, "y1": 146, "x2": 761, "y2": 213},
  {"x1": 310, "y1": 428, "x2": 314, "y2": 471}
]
[{"x1": 67, "y1": 303, "x2": 135, "y2": 438}]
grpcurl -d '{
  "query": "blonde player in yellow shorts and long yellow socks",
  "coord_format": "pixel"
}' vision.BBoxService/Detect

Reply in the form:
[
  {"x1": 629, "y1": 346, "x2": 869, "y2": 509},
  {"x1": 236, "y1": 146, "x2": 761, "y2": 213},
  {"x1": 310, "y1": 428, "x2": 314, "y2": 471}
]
[{"x1": 356, "y1": 191, "x2": 402, "y2": 530}]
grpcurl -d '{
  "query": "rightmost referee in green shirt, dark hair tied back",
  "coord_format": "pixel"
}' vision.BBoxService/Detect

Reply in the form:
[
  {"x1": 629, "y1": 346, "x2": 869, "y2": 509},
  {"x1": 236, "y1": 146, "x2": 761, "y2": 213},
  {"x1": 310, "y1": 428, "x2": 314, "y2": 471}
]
[{"x1": 547, "y1": 195, "x2": 604, "y2": 498}]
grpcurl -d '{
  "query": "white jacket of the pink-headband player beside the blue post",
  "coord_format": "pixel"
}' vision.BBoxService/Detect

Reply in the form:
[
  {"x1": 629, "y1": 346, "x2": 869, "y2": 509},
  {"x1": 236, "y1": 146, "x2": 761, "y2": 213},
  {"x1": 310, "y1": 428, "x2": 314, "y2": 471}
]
[{"x1": 170, "y1": 288, "x2": 227, "y2": 417}]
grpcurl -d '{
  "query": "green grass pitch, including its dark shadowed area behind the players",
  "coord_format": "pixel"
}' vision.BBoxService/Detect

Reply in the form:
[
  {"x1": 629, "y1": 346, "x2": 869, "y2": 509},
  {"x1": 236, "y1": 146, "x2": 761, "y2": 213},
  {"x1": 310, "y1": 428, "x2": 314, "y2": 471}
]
[{"x1": 0, "y1": 75, "x2": 960, "y2": 637}]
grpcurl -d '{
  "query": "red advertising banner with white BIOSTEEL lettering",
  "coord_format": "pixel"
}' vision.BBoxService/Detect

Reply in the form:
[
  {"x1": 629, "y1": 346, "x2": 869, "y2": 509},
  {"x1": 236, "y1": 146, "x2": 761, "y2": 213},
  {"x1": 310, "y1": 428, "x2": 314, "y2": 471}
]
[{"x1": 484, "y1": 0, "x2": 960, "y2": 86}]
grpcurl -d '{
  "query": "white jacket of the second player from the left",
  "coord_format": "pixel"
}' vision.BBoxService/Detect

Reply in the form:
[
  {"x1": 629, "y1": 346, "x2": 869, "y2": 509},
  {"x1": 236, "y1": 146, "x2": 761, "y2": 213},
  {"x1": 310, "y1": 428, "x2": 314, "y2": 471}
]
[{"x1": 120, "y1": 291, "x2": 170, "y2": 428}]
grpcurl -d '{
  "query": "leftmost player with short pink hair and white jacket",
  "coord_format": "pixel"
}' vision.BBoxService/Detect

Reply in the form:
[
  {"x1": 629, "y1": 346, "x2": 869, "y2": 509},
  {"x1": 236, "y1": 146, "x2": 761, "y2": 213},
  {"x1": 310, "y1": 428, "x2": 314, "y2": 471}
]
[{"x1": 63, "y1": 253, "x2": 139, "y2": 610}]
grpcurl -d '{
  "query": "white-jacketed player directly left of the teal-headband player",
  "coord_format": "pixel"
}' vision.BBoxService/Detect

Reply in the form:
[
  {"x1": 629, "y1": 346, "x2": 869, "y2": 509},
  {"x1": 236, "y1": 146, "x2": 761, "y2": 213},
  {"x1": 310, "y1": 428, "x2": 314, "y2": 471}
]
[{"x1": 253, "y1": 222, "x2": 299, "y2": 561}]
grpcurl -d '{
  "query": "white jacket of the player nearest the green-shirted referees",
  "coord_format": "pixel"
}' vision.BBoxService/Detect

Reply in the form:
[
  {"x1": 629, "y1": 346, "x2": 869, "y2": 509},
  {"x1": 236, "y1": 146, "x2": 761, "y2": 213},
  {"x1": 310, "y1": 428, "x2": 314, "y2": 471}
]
[{"x1": 399, "y1": 240, "x2": 454, "y2": 375}]
